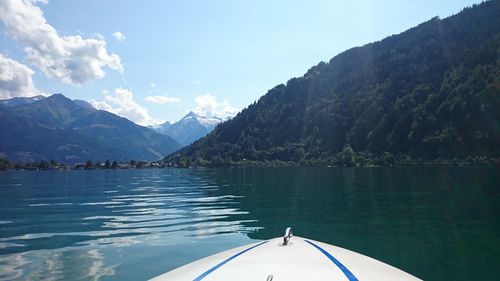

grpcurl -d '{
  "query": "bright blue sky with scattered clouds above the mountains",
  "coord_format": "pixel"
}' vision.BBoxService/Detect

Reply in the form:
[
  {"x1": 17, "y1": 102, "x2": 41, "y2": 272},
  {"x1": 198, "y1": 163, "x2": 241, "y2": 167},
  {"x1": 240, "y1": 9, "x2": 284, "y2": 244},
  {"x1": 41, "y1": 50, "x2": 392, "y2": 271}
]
[{"x1": 0, "y1": 0, "x2": 481, "y2": 125}]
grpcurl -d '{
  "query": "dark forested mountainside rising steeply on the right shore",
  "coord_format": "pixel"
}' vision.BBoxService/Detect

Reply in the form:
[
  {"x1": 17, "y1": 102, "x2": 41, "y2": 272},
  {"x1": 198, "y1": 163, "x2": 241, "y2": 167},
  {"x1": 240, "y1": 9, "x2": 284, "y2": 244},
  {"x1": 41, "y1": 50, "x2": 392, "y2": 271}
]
[{"x1": 165, "y1": 1, "x2": 500, "y2": 166}]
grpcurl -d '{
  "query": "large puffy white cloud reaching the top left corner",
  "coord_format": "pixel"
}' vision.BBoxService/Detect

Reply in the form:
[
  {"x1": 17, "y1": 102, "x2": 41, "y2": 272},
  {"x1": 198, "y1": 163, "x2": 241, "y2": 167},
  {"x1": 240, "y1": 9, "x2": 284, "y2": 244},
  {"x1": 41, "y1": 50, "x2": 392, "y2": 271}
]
[{"x1": 0, "y1": 0, "x2": 123, "y2": 85}]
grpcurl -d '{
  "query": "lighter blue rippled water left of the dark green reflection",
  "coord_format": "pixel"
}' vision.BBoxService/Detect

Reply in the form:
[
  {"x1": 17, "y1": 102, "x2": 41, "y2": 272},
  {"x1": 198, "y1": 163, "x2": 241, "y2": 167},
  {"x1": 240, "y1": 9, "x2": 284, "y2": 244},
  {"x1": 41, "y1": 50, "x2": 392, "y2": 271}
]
[{"x1": 0, "y1": 167, "x2": 262, "y2": 280}]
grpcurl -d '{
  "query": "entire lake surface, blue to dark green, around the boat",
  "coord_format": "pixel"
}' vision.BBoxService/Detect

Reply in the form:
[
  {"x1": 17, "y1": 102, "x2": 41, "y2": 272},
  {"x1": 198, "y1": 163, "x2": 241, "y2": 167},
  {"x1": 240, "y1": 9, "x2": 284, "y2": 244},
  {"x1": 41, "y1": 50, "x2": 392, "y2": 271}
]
[{"x1": 0, "y1": 167, "x2": 500, "y2": 280}]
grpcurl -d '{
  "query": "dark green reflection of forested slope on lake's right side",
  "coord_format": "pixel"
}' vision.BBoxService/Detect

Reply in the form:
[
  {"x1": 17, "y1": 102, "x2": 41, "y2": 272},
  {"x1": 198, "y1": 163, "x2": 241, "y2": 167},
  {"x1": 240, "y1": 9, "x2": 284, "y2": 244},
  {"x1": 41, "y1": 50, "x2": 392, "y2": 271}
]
[{"x1": 195, "y1": 167, "x2": 500, "y2": 280}]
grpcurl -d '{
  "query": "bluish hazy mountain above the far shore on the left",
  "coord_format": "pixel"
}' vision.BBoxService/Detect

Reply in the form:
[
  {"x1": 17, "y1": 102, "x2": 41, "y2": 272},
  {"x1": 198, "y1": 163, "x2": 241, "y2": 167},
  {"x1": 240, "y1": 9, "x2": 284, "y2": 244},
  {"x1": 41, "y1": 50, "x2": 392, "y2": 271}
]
[{"x1": 0, "y1": 94, "x2": 180, "y2": 163}]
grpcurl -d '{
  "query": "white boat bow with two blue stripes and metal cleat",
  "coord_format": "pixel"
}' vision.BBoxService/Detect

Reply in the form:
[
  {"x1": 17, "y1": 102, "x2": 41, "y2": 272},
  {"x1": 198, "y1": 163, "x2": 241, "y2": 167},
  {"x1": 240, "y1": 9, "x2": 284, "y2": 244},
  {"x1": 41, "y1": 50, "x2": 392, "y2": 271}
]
[{"x1": 152, "y1": 229, "x2": 420, "y2": 281}]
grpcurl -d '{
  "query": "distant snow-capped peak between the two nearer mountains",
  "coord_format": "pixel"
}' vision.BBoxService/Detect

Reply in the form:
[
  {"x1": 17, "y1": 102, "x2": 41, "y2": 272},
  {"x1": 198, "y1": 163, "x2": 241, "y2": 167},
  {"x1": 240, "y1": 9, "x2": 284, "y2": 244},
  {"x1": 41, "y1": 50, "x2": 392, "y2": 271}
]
[{"x1": 154, "y1": 111, "x2": 223, "y2": 146}]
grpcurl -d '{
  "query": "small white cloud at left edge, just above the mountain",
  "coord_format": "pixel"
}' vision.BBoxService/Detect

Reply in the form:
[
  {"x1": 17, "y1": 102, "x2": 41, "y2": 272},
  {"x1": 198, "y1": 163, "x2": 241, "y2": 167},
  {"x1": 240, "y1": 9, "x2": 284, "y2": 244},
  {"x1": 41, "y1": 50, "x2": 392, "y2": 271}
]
[{"x1": 0, "y1": 54, "x2": 40, "y2": 99}]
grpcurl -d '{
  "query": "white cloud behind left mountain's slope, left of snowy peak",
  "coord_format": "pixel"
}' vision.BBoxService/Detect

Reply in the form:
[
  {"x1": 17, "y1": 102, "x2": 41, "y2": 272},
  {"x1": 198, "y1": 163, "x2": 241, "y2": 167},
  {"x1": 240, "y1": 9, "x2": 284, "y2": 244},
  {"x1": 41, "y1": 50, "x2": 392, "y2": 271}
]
[{"x1": 90, "y1": 88, "x2": 164, "y2": 126}]
